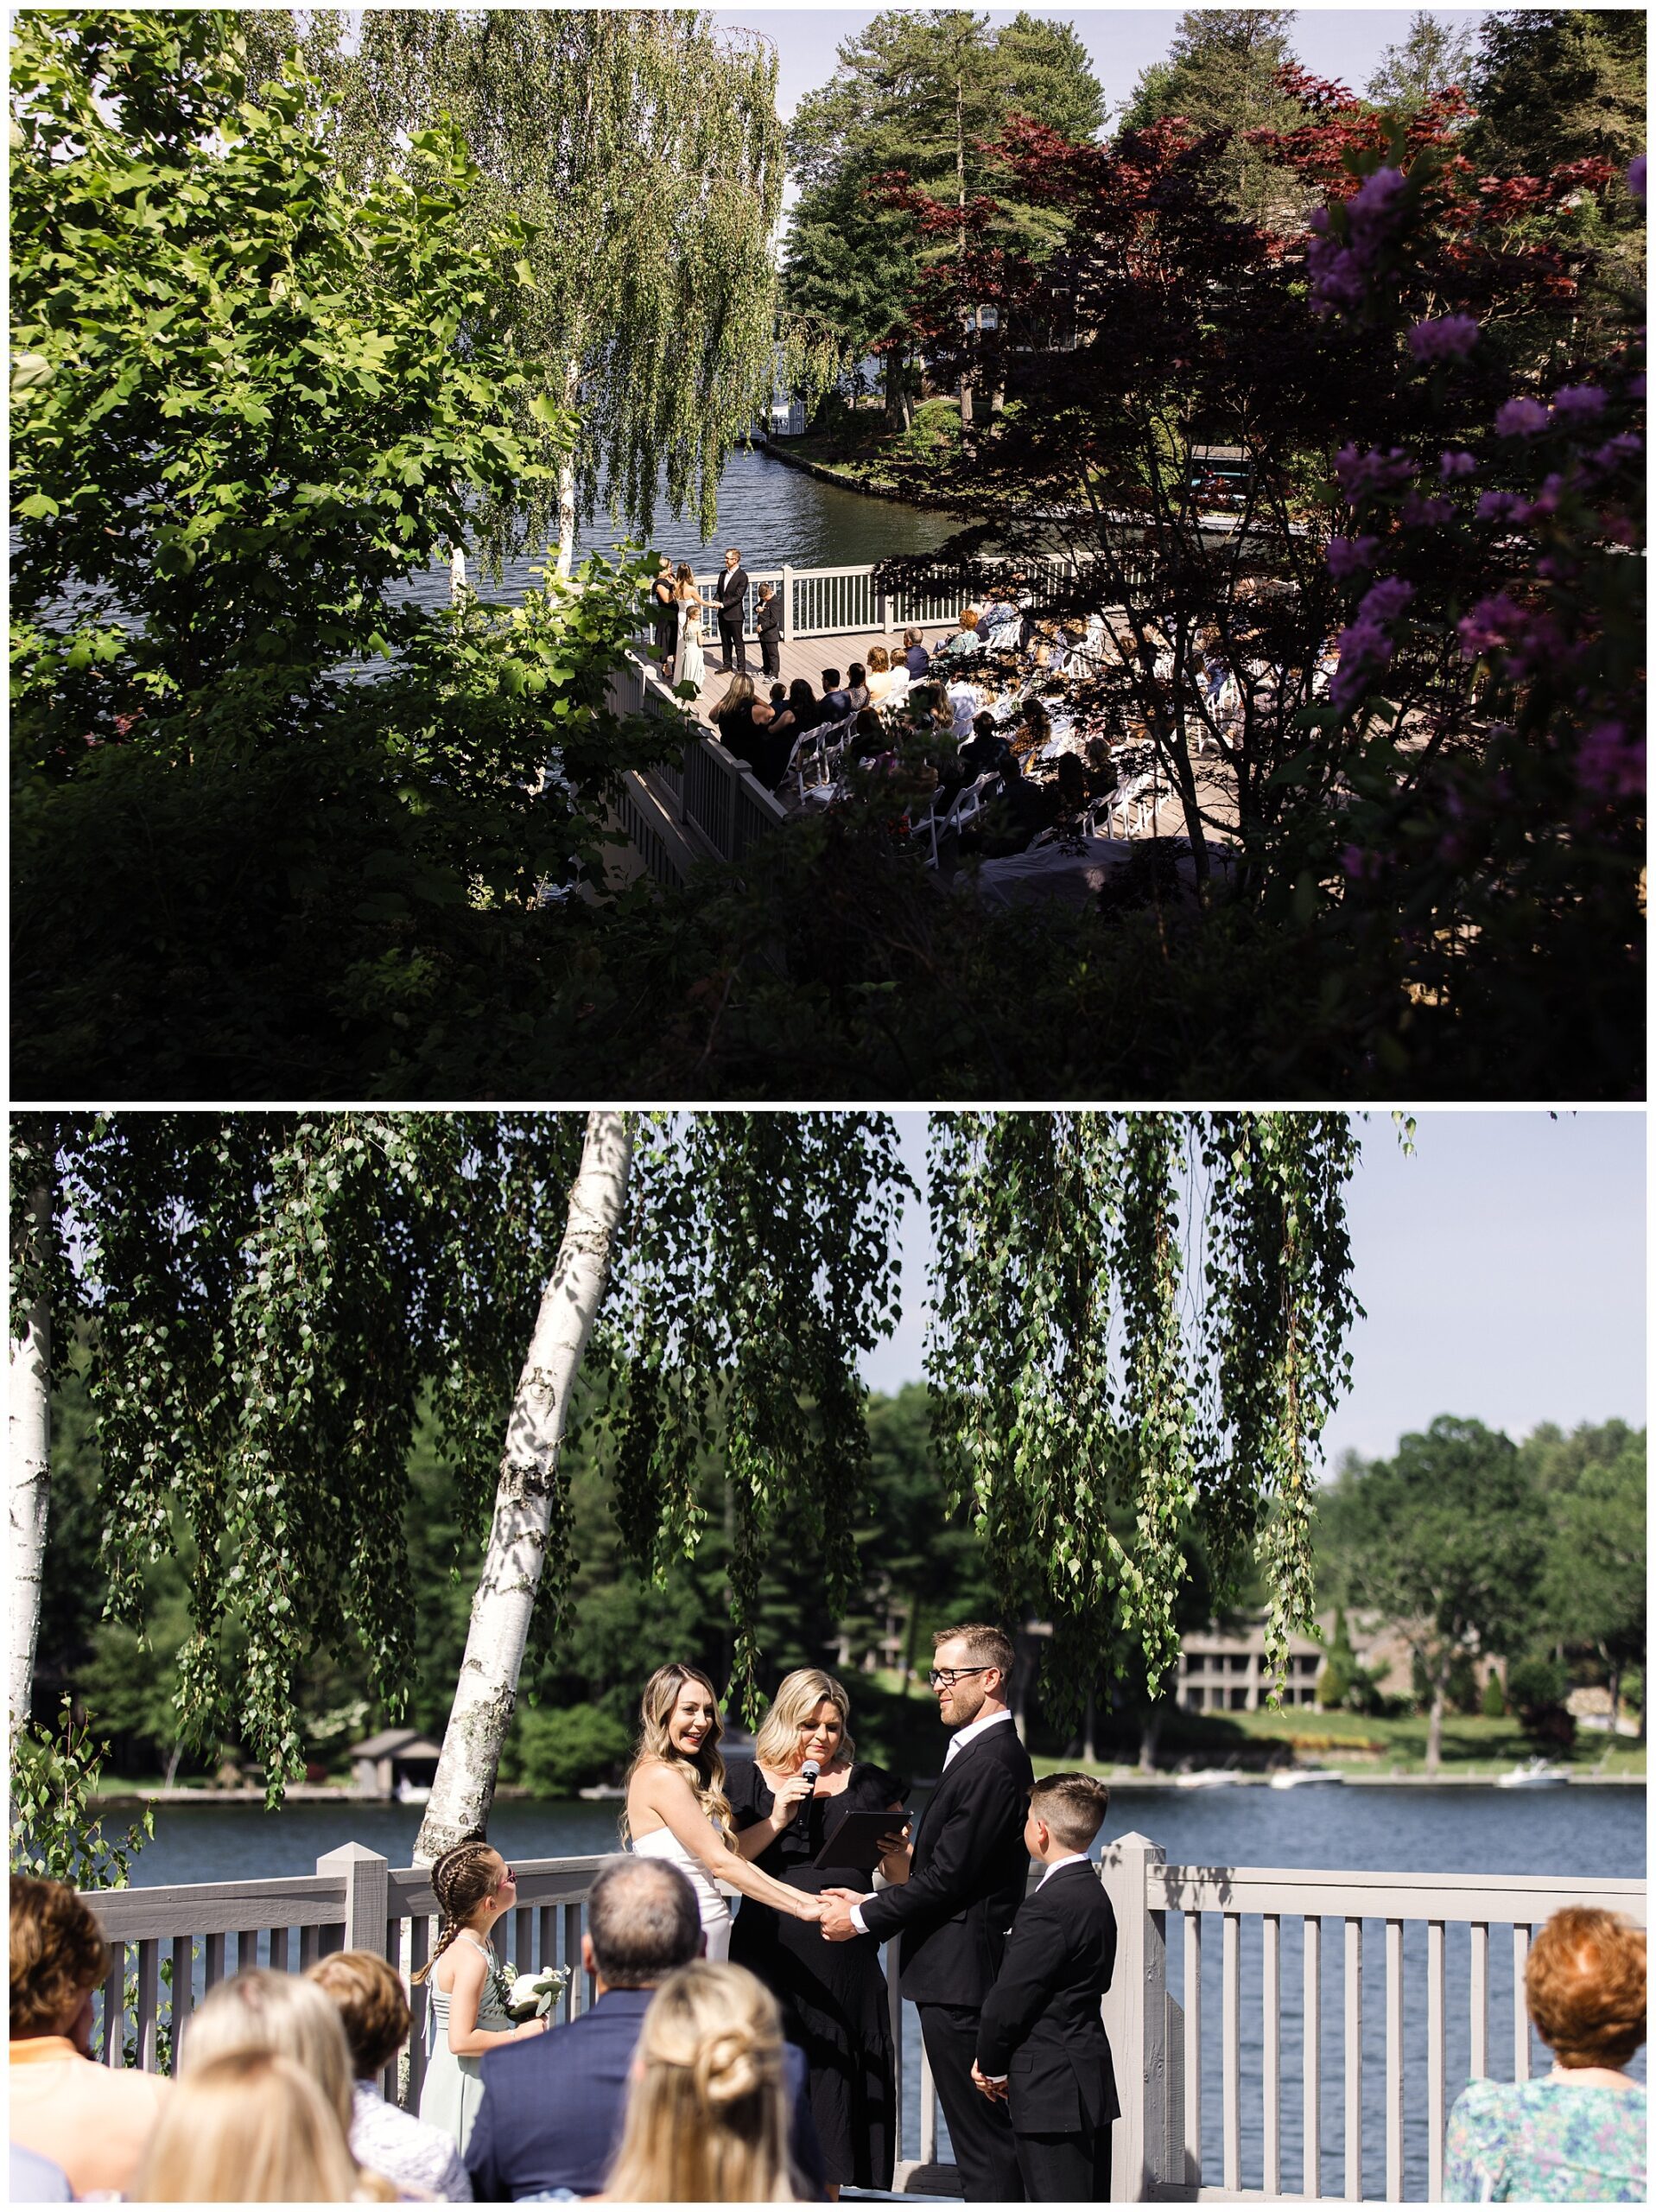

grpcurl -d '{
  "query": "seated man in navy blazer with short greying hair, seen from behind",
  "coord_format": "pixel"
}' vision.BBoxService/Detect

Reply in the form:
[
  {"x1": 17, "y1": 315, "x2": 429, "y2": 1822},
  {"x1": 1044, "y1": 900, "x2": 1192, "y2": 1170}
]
[{"x1": 466, "y1": 1858, "x2": 827, "y2": 2203}]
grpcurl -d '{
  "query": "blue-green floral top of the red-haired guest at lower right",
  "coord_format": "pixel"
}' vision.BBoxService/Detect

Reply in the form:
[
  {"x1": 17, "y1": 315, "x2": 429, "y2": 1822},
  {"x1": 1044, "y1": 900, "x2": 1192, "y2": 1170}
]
[{"x1": 1443, "y1": 2082, "x2": 1647, "y2": 2205}]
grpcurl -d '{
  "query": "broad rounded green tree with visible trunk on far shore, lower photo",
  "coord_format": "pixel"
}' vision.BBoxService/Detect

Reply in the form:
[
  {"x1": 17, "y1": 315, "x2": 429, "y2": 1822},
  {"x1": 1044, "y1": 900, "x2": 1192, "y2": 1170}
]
[{"x1": 1323, "y1": 1414, "x2": 1545, "y2": 1774}]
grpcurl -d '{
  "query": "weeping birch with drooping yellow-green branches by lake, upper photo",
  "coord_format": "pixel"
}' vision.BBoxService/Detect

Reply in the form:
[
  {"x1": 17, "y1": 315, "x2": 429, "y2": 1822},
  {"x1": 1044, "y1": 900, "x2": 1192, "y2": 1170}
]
[{"x1": 282, "y1": 9, "x2": 785, "y2": 575}]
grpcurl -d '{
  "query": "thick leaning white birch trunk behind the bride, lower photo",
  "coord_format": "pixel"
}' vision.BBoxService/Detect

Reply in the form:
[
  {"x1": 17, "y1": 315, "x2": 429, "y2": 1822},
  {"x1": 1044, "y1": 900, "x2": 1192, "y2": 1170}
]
[{"x1": 414, "y1": 1113, "x2": 632, "y2": 1867}]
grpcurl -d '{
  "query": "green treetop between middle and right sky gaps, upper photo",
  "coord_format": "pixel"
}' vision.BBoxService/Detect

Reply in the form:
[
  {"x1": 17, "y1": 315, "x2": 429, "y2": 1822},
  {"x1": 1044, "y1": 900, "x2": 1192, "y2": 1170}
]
[{"x1": 1117, "y1": 7, "x2": 1302, "y2": 224}]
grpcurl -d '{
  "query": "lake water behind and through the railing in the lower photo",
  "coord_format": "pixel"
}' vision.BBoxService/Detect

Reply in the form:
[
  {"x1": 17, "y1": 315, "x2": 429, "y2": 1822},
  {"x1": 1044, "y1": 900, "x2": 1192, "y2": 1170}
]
[{"x1": 115, "y1": 1785, "x2": 1645, "y2": 2199}]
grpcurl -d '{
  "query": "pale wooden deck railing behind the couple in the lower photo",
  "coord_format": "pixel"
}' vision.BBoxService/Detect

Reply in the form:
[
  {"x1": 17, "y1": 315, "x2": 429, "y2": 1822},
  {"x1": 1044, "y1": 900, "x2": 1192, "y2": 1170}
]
[{"x1": 77, "y1": 1836, "x2": 1645, "y2": 2203}]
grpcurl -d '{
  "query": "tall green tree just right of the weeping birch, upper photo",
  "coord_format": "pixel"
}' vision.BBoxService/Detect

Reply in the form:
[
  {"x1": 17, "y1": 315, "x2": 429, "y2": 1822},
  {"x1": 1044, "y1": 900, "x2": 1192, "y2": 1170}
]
[{"x1": 783, "y1": 9, "x2": 1103, "y2": 416}]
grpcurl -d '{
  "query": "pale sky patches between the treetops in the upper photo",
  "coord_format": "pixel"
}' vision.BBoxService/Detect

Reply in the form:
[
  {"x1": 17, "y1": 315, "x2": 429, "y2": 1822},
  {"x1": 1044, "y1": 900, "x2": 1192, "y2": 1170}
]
[{"x1": 712, "y1": 7, "x2": 1490, "y2": 118}]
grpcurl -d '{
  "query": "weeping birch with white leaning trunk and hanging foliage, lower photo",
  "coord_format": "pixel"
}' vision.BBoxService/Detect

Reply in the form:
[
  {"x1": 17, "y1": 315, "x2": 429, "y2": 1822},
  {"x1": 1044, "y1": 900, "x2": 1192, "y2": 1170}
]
[{"x1": 11, "y1": 1110, "x2": 1357, "y2": 1858}]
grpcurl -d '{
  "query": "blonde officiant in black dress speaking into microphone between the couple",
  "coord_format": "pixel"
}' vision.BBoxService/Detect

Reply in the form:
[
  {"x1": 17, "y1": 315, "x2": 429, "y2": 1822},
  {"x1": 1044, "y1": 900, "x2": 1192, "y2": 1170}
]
[{"x1": 725, "y1": 1668, "x2": 909, "y2": 2195}]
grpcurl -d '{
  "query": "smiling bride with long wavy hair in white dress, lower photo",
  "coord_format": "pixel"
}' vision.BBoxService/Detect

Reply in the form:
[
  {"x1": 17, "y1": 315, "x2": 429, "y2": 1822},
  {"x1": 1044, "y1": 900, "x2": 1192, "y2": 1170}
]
[{"x1": 621, "y1": 1666, "x2": 822, "y2": 1960}]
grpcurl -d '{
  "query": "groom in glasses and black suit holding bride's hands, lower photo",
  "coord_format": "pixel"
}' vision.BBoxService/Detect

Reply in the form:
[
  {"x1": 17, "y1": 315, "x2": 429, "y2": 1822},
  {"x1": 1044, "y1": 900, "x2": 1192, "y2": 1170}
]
[{"x1": 822, "y1": 1624, "x2": 1035, "y2": 2203}]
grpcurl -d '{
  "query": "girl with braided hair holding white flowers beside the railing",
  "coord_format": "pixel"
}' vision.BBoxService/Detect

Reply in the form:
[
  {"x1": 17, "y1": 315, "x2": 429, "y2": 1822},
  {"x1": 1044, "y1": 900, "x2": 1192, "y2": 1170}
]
[{"x1": 411, "y1": 1836, "x2": 550, "y2": 2152}]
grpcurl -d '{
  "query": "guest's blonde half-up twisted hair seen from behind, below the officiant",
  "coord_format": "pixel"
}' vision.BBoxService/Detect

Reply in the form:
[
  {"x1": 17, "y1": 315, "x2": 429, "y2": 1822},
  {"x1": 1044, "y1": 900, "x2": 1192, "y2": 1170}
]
[{"x1": 604, "y1": 1960, "x2": 798, "y2": 2205}]
